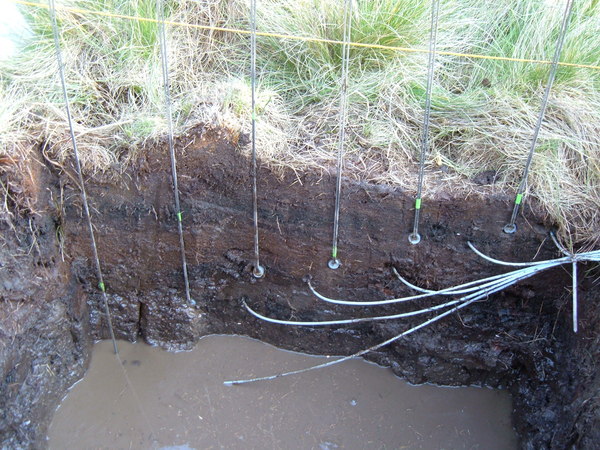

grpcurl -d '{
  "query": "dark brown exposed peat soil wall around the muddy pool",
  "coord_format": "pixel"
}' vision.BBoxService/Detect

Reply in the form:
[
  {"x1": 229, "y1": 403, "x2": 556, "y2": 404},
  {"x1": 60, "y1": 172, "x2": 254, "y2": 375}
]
[{"x1": 0, "y1": 126, "x2": 600, "y2": 449}]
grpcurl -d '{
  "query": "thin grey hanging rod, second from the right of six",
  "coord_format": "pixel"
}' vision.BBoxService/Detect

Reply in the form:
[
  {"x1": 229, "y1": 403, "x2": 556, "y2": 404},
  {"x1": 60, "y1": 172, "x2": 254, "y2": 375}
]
[{"x1": 408, "y1": 0, "x2": 440, "y2": 245}]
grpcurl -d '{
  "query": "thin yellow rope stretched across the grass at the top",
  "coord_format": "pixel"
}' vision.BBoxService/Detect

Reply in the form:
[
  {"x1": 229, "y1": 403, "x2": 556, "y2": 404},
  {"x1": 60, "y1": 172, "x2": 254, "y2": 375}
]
[{"x1": 9, "y1": 0, "x2": 600, "y2": 70}]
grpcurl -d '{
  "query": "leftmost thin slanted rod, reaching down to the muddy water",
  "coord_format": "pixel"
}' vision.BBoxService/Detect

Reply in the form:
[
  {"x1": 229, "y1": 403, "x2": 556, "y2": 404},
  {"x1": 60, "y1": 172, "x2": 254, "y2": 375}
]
[{"x1": 48, "y1": 0, "x2": 119, "y2": 356}]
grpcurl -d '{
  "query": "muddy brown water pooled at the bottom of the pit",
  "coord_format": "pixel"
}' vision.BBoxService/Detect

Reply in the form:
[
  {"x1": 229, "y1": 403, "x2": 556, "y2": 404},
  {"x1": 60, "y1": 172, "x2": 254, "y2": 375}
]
[{"x1": 49, "y1": 336, "x2": 517, "y2": 449}]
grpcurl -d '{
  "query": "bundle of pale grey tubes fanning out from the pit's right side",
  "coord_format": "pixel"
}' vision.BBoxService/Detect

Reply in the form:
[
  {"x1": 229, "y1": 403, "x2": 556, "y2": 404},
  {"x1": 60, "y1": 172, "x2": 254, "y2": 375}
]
[{"x1": 224, "y1": 235, "x2": 600, "y2": 385}]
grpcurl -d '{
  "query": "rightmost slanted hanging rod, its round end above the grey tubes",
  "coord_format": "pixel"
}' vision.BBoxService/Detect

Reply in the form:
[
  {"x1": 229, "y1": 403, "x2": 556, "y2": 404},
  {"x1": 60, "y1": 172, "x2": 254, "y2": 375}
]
[{"x1": 502, "y1": 0, "x2": 573, "y2": 234}]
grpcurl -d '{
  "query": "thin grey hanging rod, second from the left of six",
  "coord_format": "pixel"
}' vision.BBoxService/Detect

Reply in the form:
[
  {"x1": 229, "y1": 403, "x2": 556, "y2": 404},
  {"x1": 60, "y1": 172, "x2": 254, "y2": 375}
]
[{"x1": 156, "y1": 0, "x2": 196, "y2": 305}]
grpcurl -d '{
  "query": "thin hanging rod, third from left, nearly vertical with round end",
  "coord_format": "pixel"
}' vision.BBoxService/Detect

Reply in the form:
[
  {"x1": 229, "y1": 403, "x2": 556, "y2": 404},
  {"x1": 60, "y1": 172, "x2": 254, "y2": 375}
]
[{"x1": 250, "y1": 0, "x2": 265, "y2": 278}]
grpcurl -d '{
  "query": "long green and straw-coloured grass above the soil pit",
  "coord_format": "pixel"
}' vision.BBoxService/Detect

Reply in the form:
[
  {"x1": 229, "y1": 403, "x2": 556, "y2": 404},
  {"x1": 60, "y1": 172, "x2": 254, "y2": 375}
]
[{"x1": 0, "y1": 0, "x2": 600, "y2": 245}]
